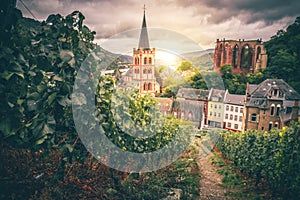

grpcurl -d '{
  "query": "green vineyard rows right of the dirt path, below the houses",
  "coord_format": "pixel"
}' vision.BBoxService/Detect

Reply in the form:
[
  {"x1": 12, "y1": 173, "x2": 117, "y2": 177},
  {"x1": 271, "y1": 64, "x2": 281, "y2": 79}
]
[{"x1": 217, "y1": 124, "x2": 300, "y2": 199}]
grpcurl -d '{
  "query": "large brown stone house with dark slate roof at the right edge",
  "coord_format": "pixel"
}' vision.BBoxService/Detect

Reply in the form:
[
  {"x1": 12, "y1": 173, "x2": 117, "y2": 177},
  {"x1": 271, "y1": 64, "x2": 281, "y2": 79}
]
[{"x1": 243, "y1": 79, "x2": 300, "y2": 131}]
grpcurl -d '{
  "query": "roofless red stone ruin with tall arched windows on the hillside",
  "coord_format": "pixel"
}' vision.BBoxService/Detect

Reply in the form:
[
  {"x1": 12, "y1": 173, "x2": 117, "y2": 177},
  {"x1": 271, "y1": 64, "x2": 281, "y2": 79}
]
[{"x1": 214, "y1": 38, "x2": 268, "y2": 74}]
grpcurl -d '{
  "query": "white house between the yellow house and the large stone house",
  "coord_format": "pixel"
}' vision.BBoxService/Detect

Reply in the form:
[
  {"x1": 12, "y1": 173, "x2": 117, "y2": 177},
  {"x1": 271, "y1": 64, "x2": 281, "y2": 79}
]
[{"x1": 223, "y1": 93, "x2": 245, "y2": 131}]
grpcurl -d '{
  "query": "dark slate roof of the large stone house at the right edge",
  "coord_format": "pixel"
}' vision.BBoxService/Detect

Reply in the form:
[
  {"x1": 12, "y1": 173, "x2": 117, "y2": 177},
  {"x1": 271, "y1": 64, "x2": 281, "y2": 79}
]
[{"x1": 248, "y1": 79, "x2": 300, "y2": 100}]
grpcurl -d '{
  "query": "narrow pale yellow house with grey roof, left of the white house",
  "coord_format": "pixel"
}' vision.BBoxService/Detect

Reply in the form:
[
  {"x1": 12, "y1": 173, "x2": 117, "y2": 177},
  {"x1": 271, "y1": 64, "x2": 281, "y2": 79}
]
[{"x1": 207, "y1": 88, "x2": 228, "y2": 128}]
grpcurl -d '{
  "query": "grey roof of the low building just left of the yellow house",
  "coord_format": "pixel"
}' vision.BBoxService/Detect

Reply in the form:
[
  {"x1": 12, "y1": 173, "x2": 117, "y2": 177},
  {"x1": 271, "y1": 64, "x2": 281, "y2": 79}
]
[{"x1": 176, "y1": 88, "x2": 209, "y2": 101}]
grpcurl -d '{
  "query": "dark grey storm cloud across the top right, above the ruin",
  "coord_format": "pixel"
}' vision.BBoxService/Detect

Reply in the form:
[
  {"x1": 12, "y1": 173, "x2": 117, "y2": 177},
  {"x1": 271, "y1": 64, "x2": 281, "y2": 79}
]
[{"x1": 173, "y1": 0, "x2": 300, "y2": 24}]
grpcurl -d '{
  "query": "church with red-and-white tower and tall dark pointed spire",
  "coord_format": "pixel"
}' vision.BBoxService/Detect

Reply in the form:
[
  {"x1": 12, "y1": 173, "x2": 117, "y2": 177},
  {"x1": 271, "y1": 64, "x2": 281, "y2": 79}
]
[{"x1": 122, "y1": 8, "x2": 162, "y2": 95}]
